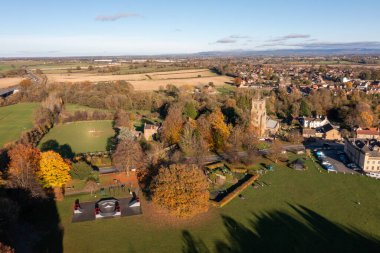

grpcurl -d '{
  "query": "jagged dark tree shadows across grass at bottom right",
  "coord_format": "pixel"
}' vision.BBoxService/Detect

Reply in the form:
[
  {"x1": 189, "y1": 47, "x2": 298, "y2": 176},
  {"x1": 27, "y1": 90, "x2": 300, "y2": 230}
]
[{"x1": 183, "y1": 206, "x2": 380, "y2": 253}]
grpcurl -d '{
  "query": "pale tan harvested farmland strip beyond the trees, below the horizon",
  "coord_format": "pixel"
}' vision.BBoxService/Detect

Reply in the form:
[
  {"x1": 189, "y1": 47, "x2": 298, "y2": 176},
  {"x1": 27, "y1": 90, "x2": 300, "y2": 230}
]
[{"x1": 47, "y1": 69, "x2": 232, "y2": 90}]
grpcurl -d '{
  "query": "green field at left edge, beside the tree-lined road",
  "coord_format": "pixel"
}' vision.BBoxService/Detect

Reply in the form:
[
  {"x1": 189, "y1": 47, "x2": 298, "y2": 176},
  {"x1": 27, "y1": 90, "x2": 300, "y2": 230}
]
[{"x1": 0, "y1": 103, "x2": 38, "y2": 147}]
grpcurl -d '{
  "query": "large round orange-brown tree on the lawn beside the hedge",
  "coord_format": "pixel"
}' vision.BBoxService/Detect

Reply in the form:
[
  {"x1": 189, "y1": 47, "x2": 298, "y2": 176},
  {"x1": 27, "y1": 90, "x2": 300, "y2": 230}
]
[{"x1": 151, "y1": 164, "x2": 210, "y2": 217}]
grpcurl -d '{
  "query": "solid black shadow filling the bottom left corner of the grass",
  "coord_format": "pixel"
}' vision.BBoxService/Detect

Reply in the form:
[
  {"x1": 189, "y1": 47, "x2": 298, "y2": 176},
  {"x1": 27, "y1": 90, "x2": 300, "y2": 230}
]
[{"x1": 0, "y1": 188, "x2": 63, "y2": 253}]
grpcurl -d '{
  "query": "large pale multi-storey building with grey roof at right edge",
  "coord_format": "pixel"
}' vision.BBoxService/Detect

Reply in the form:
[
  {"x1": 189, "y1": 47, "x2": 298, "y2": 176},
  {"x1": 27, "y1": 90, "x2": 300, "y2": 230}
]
[{"x1": 344, "y1": 139, "x2": 380, "y2": 173}]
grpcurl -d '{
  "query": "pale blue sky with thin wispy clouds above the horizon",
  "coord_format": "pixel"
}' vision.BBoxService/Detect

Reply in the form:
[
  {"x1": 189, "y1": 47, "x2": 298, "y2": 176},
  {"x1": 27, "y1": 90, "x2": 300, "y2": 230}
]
[{"x1": 0, "y1": 0, "x2": 380, "y2": 57}]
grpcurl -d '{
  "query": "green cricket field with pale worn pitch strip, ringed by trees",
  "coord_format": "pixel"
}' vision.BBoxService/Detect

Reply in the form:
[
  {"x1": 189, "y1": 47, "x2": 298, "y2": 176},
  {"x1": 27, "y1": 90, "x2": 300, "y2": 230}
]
[{"x1": 39, "y1": 120, "x2": 115, "y2": 153}]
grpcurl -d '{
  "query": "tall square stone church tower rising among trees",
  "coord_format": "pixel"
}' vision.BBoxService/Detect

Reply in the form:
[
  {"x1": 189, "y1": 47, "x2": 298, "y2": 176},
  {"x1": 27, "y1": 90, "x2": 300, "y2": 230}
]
[{"x1": 251, "y1": 99, "x2": 267, "y2": 137}]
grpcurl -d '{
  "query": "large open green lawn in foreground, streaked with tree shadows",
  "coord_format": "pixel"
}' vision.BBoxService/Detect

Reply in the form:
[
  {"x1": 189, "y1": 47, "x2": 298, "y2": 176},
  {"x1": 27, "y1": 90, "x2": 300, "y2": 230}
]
[{"x1": 58, "y1": 158, "x2": 380, "y2": 253}]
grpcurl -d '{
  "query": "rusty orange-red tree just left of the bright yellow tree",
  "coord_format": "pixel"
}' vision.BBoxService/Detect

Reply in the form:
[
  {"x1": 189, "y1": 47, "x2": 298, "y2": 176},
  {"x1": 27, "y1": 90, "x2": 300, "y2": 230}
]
[{"x1": 8, "y1": 144, "x2": 40, "y2": 195}]
